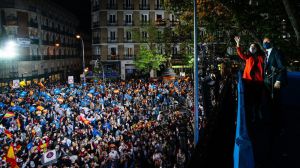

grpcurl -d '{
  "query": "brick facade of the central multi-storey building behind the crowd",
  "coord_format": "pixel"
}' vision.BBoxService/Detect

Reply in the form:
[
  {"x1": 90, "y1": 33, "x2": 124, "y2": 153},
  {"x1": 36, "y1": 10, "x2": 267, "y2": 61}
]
[{"x1": 91, "y1": 0, "x2": 183, "y2": 79}]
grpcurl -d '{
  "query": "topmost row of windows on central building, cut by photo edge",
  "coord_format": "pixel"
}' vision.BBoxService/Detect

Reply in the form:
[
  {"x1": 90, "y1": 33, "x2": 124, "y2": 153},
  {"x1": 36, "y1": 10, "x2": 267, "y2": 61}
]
[{"x1": 92, "y1": 0, "x2": 164, "y2": 9}]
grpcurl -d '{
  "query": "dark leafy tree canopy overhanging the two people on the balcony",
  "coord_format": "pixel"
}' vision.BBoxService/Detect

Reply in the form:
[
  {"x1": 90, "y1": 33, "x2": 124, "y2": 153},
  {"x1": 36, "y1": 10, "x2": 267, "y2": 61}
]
[{"x1": 166, "y1": 0, "x2": 300, "y2": 62}]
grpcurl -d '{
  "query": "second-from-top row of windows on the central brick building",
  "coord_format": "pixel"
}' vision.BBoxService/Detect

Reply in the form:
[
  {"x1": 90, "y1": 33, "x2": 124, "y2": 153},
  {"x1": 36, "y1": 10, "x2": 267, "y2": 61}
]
[{"x1": 92, "y1": 12, "x2": 175, "y2": 25}]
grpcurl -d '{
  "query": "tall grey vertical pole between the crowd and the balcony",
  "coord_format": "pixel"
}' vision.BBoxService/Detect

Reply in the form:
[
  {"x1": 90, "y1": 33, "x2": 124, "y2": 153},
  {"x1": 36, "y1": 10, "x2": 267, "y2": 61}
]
[{"x1": 194, "y1": 0, "x2": 199, "y2": 147}]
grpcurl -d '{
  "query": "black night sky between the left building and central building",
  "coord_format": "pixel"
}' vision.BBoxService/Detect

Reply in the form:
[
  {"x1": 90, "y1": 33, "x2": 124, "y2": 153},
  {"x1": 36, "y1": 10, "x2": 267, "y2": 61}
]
[{"x1": 51, "y1": 0, "x2": 91, "y2": 33}]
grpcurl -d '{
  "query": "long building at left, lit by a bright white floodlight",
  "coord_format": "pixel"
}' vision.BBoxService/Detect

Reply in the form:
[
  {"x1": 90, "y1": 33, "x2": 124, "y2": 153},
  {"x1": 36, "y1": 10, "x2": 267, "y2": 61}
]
[{"x1": 0, "y1": 0, "x2": 82, "y2": 85}]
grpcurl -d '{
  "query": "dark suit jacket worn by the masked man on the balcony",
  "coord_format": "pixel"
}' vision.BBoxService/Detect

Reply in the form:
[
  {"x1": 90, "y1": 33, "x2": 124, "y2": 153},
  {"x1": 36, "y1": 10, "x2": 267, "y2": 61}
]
[{"x1": 264, "y1": 48, "x2": 287, "y2": 86}]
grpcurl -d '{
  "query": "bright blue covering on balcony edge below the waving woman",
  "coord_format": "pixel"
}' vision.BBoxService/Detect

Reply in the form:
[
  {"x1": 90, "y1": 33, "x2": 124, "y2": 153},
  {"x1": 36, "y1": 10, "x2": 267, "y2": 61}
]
[{"x1": 233, "y1": 73, "x2": 254, "y2": 168}]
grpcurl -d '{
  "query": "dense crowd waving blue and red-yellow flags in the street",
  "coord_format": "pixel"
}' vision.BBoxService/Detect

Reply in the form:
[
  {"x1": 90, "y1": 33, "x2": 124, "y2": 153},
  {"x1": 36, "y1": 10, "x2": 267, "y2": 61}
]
[{"x1": 0, "y1": 80, "x2": 197, "y2": 168}]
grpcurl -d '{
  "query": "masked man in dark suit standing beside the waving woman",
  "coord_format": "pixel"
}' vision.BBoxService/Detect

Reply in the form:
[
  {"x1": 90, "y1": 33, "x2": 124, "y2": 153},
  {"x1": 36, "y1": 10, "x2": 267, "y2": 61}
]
[{"x1": 263, "y1": 37, "x2": 287, "y2": 154}]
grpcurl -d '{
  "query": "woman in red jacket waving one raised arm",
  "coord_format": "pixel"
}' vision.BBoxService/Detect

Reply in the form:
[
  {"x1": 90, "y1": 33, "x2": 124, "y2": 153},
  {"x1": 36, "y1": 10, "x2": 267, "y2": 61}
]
[{"x1": 234, "y1": 37, "x2": 265, "y2": 139}]
